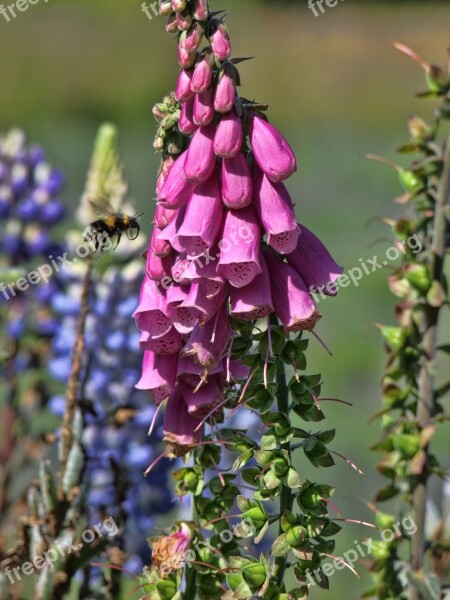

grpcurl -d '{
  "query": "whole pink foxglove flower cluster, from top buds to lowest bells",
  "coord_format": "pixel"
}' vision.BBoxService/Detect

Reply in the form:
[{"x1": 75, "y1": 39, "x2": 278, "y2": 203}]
[{"x1": 134, "y1": 0, "x2": 342, "y2": 455}]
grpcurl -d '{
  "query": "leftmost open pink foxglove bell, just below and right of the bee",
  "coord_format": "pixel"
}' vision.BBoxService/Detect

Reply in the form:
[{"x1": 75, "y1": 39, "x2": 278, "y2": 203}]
[{"x1": 133, "y1": 277, "x2": 172, "y2": 337}]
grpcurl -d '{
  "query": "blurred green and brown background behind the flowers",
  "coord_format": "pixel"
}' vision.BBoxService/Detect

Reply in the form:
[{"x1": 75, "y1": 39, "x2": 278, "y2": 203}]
[{"x1": 0, "y1": 0, "x2": 450, "y2": 599}]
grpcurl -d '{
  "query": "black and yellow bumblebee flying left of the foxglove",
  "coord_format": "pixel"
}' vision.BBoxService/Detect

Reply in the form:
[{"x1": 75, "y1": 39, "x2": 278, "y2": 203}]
[{"x1": 83, "y1": 200, "x2": 144, "y2": 252}]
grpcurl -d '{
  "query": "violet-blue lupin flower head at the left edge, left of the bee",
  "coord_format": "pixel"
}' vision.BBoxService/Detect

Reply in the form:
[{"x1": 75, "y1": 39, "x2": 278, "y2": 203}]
[{"x1": 0, "y1": 129, "x2": 64, "y2": 265}]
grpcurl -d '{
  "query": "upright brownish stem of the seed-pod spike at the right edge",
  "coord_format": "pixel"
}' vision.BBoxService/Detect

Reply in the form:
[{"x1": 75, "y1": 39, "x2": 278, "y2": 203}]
[{"x1": 408, "y1": 136, "x2": 450, "y2": 600}]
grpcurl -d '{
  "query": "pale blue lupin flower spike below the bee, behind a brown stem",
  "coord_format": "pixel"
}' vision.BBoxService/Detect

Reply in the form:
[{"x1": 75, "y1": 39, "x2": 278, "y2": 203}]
[{"x1": 49, "y1": 261, "x2": 172, "y2": 571}]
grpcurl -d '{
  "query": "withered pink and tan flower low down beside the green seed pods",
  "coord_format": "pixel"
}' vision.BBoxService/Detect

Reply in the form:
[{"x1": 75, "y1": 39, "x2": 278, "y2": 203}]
[{"x1": 152, "y1": 523, "x2": 193, "y2": 579}]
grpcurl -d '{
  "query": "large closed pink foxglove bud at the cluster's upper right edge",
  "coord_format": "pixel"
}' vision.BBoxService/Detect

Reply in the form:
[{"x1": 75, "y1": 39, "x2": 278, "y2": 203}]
[{"x1": 249, "y1": 112, "x2": 297, "y2": 181}]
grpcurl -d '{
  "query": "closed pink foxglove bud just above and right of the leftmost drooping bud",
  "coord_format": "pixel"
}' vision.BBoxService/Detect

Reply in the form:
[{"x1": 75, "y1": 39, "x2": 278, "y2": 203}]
[{"x1": 184, "y1": 125, "x2": 216, "y2": 182}]
